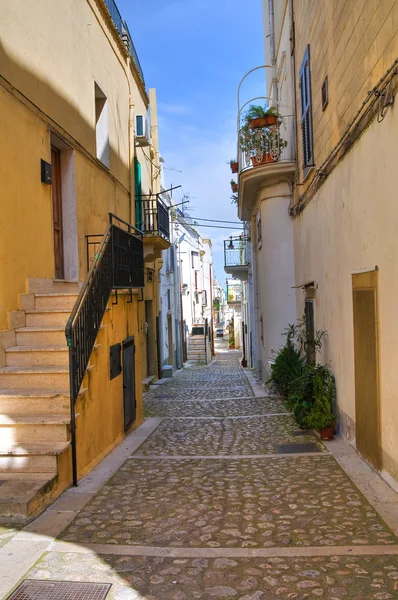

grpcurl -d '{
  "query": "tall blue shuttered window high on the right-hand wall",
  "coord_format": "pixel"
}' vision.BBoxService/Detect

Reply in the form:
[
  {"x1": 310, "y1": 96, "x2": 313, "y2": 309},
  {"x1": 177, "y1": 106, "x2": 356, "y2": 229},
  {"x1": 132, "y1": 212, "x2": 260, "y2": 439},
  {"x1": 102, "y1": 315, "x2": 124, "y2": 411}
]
[{"x1": 300, "y1": 45, "x2": 314, "y2": 169}]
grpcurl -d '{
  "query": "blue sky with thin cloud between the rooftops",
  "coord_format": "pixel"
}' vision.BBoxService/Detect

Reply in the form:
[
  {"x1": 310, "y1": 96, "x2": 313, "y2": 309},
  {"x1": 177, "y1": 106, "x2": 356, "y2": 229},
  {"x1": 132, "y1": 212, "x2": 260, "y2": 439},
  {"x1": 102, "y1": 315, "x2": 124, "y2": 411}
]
[{"x1": 117, "y1": 0, "x2": 264, "y2": 282}]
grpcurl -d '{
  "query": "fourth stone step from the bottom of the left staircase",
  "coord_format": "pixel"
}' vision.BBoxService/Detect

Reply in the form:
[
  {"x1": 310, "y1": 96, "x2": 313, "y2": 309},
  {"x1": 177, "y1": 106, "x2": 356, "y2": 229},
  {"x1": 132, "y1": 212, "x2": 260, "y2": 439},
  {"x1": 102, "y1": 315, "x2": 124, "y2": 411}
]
[{"x1": 0, "y1": 388, "x2": 69, "y2": 412}]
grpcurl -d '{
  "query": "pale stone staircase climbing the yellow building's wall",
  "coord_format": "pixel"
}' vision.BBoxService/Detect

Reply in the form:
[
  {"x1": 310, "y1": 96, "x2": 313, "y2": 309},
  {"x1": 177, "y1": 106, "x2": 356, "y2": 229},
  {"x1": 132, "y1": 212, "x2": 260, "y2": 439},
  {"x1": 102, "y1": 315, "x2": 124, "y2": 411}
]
[{"x1": 0, "y1": 282, "x2": 78, "y2": 522}]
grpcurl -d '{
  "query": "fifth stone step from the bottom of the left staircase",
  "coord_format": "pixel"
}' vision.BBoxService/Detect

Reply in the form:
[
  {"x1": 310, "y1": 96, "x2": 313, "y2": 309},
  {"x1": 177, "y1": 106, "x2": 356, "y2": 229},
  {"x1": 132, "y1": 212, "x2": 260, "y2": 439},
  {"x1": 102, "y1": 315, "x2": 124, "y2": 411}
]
[{"x1": 0, "y1": 366, "x2": 69, "y2": 390}]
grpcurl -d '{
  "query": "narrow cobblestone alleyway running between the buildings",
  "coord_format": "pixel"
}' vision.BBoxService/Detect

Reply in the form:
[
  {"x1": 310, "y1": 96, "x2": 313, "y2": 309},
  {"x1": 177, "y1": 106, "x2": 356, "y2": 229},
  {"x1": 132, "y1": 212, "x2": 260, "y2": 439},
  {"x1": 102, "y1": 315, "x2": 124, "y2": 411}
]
[{"x1": 0, "y1": 341, "x2": 398, "y2": 600}]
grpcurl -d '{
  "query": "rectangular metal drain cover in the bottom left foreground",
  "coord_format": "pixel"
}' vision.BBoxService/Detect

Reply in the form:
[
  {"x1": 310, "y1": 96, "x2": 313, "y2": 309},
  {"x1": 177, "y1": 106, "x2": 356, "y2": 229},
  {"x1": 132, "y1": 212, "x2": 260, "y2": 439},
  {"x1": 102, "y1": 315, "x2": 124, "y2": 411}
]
[{"x1": 8, "y1": 579, "x2": 112, "y2": 600}]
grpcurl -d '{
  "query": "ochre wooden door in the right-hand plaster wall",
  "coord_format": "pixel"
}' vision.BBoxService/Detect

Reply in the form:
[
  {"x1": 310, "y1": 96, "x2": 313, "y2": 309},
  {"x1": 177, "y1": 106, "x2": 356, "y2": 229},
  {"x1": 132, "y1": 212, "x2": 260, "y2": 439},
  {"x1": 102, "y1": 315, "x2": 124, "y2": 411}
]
[{"x1": 352, "y1": 271, "x2": 382, "y2": 469}]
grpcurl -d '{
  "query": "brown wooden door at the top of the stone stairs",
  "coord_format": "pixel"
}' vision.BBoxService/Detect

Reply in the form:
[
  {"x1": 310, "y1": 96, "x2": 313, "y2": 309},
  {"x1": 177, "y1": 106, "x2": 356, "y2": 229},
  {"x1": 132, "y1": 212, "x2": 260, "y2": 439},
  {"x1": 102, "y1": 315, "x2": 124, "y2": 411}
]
[{"x1": 51, "y1": 146, "x2": 64, "y2": 279}]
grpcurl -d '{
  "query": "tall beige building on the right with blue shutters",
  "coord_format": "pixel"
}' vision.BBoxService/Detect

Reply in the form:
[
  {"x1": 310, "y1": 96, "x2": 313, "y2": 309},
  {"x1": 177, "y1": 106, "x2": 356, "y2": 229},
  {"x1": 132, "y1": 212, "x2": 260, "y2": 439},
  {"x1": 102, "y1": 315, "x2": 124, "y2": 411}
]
[{"x1": 239, "y1": 0, "x2": 398, "y2": 482}]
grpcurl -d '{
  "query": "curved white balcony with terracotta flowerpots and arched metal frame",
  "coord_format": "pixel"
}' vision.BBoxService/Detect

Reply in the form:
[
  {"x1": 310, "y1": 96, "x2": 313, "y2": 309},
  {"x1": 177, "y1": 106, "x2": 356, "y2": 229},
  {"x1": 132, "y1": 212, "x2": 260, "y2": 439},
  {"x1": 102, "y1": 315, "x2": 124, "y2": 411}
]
[{"x1": 237, "y1": 65, "x2": 296, "y2": 220}]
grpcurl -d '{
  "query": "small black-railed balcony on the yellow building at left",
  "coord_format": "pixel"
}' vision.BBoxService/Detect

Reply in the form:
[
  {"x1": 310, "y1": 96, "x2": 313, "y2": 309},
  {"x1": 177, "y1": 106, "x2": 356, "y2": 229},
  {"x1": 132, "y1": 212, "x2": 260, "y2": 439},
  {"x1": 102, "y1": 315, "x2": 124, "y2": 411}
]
[{"x1": 135, "y1": 195, "x2": 170, "y2": 262}]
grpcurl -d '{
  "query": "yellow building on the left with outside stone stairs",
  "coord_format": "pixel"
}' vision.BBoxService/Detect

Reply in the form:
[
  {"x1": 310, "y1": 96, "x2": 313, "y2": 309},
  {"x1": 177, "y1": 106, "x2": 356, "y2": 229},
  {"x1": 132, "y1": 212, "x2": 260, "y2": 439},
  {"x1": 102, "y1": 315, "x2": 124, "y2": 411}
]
[{"x1": 0, "y1": 0, "x2": 168, "y2": 520}]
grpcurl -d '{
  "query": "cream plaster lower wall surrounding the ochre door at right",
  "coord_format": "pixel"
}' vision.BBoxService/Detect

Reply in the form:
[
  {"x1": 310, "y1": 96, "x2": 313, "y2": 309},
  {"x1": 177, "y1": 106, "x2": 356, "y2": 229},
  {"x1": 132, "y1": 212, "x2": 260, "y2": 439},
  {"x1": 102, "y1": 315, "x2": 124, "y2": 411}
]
[{"x1": 294, "y1": 107, "x2": 398, "y2": 477}]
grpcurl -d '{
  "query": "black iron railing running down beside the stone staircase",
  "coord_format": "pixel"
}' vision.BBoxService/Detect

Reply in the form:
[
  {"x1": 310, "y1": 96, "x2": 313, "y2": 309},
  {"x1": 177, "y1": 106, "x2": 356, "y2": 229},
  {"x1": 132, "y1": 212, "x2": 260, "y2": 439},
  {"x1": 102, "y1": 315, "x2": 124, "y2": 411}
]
[{"x1": 65, "y1": 213, "x2": 144, "y2": 485}]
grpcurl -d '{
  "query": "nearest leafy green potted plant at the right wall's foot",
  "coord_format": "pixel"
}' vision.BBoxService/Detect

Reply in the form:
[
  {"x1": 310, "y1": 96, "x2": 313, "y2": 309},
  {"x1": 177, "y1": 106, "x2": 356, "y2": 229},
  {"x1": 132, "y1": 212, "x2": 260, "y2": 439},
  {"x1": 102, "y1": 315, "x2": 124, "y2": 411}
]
[{"x1": 305, "y1": 365, "x2": 336, "y2": 440}]
